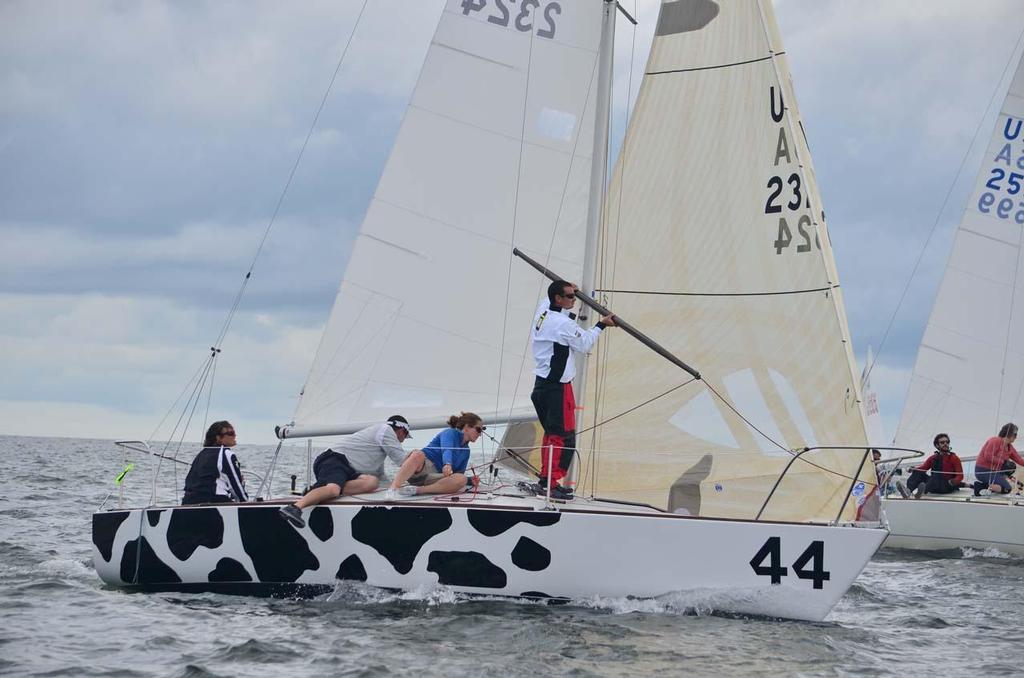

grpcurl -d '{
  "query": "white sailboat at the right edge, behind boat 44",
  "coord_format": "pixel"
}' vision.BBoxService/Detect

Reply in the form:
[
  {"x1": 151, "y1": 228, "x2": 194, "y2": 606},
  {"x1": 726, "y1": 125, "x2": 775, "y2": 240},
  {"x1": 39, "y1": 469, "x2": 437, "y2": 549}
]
[{"x1": 885, "y1": 39, "x2": 1024, "y2": 555}]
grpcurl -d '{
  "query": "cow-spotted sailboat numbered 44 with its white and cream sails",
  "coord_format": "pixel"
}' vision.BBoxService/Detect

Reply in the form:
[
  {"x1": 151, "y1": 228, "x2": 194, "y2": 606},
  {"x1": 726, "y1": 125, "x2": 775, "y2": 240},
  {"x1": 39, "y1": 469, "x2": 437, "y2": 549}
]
[{"x1": 93, "y1": 0, "x2": 887, "y2": 621}]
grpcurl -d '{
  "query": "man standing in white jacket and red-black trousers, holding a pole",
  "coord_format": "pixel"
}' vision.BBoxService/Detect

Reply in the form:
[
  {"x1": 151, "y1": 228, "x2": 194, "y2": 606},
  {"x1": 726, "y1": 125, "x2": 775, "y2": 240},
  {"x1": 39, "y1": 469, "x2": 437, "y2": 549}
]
[{"x1": 529, "y1": 281, "x2": 615, "y2": 499}]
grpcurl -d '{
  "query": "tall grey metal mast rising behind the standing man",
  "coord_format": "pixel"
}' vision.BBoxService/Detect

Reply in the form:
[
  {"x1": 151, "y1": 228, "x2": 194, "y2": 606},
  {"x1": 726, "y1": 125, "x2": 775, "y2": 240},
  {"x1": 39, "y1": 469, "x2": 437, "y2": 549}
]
[{"x1": 569, "y1": 0, "x2": 617, "y2": 467}]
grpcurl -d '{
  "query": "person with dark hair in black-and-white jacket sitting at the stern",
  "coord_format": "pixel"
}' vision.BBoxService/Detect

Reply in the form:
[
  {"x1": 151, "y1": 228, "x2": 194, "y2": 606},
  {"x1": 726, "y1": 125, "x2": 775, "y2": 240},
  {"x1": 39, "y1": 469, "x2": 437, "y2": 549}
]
[{"x1": 181, "y1": 421, "x2": 249, "y2": 504}]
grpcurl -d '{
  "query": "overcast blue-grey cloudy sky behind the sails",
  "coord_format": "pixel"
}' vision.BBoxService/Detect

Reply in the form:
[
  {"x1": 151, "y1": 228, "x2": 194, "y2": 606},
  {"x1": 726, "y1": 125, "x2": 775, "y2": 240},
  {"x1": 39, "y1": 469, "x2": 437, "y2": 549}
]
[{"x1": 0, "y1": 0, "x2": 1024, "y2": 442}]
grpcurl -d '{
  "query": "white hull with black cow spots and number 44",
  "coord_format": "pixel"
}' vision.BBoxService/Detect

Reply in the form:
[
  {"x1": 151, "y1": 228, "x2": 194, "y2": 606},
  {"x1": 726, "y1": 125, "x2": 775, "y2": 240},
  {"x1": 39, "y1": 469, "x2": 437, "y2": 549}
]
[{"x1": 92, "y1": 495, "x2": 886, "y2": 621}]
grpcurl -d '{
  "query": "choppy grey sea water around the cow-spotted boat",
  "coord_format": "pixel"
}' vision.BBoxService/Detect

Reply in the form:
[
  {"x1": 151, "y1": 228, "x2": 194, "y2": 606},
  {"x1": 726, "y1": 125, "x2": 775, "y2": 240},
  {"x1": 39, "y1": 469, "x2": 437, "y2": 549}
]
[{"x1": 0, "y1": 437, "x2": 1024, "y2": 676}]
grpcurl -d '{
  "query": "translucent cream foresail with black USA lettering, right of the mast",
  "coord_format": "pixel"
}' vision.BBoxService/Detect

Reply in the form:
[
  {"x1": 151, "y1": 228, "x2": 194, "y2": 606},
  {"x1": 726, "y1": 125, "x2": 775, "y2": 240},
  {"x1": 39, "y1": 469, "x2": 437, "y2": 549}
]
[{"x1": 582, "y1": 0, "x2": 873, "y2": 520}]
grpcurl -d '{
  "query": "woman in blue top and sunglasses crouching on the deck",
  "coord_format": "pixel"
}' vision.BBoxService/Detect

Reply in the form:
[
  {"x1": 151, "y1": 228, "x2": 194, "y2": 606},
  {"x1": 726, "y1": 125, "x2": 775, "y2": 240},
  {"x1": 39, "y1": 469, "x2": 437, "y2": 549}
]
[{"x1": 388, "y1": 412, "x2": 487, "y2": 498}]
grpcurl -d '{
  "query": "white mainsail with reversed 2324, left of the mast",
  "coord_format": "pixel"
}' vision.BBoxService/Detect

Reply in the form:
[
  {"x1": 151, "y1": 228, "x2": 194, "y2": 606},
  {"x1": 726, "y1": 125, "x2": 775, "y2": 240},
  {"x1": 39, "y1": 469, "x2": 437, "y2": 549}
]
[{"x1": 295, "y1": 0, "x2": 601, "y2": 426}]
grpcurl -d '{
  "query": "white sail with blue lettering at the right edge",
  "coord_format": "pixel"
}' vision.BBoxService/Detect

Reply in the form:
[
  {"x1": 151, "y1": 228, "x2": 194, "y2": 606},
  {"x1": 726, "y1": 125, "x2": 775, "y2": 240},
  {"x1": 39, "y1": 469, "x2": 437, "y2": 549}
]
[{"x1": 896, "y1": 51, "x2": 1024, "y2": 454}]
